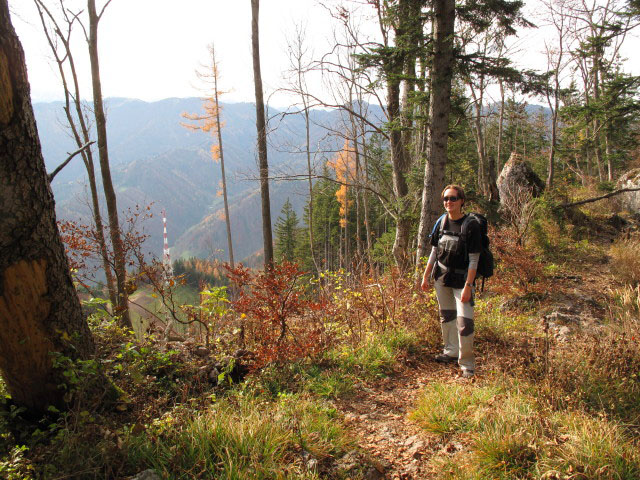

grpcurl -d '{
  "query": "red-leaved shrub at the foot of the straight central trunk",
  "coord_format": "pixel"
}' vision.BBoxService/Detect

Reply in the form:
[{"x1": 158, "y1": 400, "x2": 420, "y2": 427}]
[{"x1": 225, "y1": 261, "x2": 327, "y2": 368}]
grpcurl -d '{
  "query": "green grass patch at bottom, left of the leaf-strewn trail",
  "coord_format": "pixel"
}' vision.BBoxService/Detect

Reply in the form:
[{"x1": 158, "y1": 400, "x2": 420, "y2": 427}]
[{"x1": 126, "y1": 395, "x2": 352, "y2": 479}]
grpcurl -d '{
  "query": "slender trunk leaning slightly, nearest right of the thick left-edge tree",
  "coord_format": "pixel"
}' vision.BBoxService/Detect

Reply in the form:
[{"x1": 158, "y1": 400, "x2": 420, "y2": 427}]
[{"x1": 88, "y1": 0, "x2": 131, "y2": 328}]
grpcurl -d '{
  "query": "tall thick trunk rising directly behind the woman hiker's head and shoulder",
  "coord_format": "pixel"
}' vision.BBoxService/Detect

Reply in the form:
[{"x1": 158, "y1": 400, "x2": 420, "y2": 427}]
[{"x1": 416, "y1": 0, "x2": 455, "y2": 265}]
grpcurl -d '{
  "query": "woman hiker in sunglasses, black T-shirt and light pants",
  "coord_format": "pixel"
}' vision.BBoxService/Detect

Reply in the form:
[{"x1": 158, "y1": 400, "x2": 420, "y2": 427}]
[{"x1": 421, "y1": 185, "x2": 482, "y2": 378}]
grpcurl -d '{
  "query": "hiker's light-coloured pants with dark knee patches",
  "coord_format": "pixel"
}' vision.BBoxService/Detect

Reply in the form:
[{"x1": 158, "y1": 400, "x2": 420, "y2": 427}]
[{"x1": 434, "y1": 275, "x2": 476, "y2": 371}]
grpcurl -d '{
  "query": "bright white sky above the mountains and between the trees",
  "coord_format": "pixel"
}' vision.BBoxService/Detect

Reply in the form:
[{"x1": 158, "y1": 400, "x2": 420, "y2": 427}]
[{"x1": 9, "y1": 0, "x2": 640, "y2": 106}]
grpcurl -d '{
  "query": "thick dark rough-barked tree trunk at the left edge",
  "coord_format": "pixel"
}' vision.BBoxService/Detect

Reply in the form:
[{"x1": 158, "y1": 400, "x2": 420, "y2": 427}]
[{"x1": 0, "y1": 0, "x2": 94, "y2": 412}]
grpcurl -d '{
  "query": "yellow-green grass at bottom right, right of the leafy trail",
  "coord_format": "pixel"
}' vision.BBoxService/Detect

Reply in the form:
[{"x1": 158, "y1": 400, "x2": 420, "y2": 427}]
[{"x1": 411, "y1": 381, "x2": 640, "y2": 480}]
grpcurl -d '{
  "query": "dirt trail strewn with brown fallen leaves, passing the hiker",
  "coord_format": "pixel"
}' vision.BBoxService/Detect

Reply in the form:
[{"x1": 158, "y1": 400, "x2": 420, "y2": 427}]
[{"x1": 337, "y1": 253, "x2": 612, "y2": 480}]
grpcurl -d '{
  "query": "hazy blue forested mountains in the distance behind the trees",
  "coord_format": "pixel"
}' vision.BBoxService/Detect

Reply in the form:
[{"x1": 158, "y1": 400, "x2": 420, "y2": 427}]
[{"x1": 34, "y1": 98, "x2": 379, "y2": 260}]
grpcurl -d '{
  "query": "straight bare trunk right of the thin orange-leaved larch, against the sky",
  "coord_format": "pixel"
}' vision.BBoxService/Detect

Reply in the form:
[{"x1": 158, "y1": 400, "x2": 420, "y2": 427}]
[{"x1": 251, "y1": 0, "x2": 273, "y2": 270}]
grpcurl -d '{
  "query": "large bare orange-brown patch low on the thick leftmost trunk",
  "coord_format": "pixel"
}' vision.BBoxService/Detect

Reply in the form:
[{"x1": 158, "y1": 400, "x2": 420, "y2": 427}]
[{"x1": 0, "y1": 259, "x2": 57, "y2": 406}]
